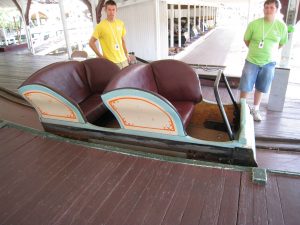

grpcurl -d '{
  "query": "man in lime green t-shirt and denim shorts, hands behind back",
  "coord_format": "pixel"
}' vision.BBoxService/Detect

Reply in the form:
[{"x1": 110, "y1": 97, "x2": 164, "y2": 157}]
[{"x1": 239, "y1": 0, "x2": 288, "y2": 121}]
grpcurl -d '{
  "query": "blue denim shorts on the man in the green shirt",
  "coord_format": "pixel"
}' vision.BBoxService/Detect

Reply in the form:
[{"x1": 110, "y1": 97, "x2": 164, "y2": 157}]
[{"x1": 239, "y1": 60, "x2": 276, "y2": 93}]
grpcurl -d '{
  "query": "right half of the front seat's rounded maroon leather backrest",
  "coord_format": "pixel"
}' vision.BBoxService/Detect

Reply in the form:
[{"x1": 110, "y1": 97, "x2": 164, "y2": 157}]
[{"x1": 151, "y1": 59, "x2": 202, "y2": 103}]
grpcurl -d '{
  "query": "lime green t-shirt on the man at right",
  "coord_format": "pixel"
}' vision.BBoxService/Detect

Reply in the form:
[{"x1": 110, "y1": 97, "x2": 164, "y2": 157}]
[{"x1": 244, "y1": 18, "x2": 288, "y2": 66}]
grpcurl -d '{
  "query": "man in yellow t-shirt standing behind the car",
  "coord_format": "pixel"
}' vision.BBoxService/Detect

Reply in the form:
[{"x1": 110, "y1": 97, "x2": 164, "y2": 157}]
[{"x1": 89, "y1": 0, "x2": 130, "y2": 69}]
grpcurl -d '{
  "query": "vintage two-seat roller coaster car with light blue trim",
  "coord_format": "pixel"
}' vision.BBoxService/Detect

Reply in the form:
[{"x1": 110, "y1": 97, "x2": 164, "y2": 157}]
[{"x1": 19, "y1": 59, "x2": 257, "y2": 166}]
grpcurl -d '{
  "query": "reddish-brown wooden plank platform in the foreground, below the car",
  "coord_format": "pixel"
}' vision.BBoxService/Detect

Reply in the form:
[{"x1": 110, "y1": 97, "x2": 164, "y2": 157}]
[{"x1": 0, "y1": 126, "x2": 300, "y2": 225}]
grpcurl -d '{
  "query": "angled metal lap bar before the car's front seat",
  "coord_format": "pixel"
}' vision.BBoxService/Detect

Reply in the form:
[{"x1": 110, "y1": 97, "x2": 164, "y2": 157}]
[{"x1": 214, "y1": 70, "x2": 240, "y2": 140}]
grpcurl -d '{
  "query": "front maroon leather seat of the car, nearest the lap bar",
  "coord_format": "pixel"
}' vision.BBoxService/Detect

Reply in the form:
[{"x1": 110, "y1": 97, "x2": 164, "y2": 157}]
[{"x1": 104, "y1": 60, "x2": 202, "y2": 128}]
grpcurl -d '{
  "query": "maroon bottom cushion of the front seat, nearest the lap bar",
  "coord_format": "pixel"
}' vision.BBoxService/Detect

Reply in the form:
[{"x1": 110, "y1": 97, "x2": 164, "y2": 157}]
[{"x1": 171, "y1": 101, "x2": 195, "y2": 129}]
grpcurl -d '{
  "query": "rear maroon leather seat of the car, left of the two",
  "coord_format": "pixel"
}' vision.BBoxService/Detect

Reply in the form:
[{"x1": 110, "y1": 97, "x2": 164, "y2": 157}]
[{"x1": 21, "y1": 58, "x2": 120, "y2": 122}]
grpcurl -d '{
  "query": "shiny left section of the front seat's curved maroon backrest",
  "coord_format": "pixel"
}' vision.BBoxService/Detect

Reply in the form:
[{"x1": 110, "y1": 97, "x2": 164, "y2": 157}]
[{"x1": 104, "y1": 64, "x2": 157, "y2": 92}]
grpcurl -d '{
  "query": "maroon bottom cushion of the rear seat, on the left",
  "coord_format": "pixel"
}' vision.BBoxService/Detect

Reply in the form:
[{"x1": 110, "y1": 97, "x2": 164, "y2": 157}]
[{"x1": 79, "y1": 94, "x2": 107, "y2": 123}]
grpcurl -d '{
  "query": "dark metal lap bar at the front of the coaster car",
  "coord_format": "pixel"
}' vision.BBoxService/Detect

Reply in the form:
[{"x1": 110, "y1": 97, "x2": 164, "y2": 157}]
[{"x1": 214, "y1": 70, "x2": 236, "y2": 140}]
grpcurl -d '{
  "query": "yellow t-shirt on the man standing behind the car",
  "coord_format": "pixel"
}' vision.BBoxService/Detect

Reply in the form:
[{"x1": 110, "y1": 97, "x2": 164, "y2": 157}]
[{"x1": 93, "y1": 19, "x2": 127, "y2": 63}]
